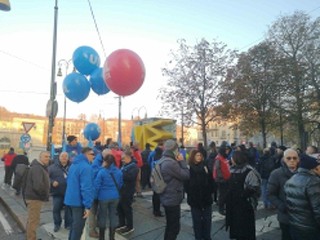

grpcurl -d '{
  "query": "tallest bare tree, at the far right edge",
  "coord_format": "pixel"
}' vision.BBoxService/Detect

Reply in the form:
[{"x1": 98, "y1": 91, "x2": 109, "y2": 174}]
[{"x1": 268, "y1": 12, "x2": 320, "y2": 148}]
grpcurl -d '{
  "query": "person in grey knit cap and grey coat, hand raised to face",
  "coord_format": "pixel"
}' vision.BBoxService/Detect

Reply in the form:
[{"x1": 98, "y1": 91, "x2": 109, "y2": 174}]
[{"x1": 160, "y1": 139, "x2": 189, "y2": 240}]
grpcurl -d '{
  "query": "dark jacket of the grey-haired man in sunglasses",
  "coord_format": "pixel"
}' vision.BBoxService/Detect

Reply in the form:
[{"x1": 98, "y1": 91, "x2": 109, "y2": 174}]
[{"x1": 267, "y1": 161, "x2": 294, "y2": 224}]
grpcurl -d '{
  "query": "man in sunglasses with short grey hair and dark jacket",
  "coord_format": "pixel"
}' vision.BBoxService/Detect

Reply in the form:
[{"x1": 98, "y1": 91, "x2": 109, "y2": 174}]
[{"x1": 267, "y1": 148, "x2": 299, "y2": 240}]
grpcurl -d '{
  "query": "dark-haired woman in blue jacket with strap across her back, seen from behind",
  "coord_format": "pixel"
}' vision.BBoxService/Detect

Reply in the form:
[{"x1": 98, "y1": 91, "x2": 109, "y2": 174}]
[{"x1": 94, "y1": 154, "x2": 123, "y2": 240}]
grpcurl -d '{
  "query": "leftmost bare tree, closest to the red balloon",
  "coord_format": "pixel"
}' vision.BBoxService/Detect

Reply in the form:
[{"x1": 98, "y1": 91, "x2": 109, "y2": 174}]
[{"x1": 159, "y1": 39, "x2": 236, "y2": 147}]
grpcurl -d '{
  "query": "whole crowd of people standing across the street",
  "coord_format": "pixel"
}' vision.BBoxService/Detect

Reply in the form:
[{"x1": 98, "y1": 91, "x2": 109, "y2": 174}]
[{"x1": 2, "y1": 136, "x2": 320, "y2": 240}]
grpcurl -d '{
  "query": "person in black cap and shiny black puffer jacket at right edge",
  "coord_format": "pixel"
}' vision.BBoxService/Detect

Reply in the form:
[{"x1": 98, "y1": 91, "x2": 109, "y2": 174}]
[{"x1": 284, "y1": 155, "x2": 320, "y2": 240}]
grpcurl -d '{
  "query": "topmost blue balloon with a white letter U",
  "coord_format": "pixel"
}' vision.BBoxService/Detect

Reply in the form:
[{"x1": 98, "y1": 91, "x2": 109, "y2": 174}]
[{"x1": 72, "y1": 46, "x2": 100, "y2": 75}]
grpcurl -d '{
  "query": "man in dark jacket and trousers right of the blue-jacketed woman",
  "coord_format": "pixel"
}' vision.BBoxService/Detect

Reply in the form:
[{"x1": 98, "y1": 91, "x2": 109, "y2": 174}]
[{"x1": 116, "y1": 146, "x2": 139, "y2": 235}]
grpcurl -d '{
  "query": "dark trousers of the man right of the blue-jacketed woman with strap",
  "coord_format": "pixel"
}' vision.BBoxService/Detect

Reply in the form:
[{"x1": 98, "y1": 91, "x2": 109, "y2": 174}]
[{"x1": 117, "y1": 196, "x2": 133, "y2": 228}]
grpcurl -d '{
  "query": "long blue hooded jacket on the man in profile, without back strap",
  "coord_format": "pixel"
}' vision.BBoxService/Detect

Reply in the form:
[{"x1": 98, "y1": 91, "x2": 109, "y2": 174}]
[{"x1": 64, "y1": 154, "x2": 94, "y2": 209}]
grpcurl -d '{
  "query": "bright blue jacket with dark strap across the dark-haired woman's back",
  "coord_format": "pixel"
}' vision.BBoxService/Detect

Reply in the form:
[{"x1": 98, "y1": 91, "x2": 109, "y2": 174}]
[{"x1": 94, "y1": 164, "x2": 123, "y2": 201}]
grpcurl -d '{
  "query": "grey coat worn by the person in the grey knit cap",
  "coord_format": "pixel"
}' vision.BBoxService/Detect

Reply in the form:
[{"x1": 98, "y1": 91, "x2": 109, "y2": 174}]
[{"x1": 160, "y1": 151, "x2": 190, "y2": 206}]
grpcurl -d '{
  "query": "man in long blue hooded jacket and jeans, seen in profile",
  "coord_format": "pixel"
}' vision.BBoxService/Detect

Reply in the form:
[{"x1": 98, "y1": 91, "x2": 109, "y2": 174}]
[{"x1": 64, "y1": 147, "x2": 94, "y2": 240}]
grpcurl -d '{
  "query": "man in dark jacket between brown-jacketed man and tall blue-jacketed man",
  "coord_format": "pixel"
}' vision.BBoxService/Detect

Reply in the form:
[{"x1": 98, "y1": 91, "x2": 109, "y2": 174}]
[{"x1": 48, "y1": 152, "x2": 71, "y2": 232}]
